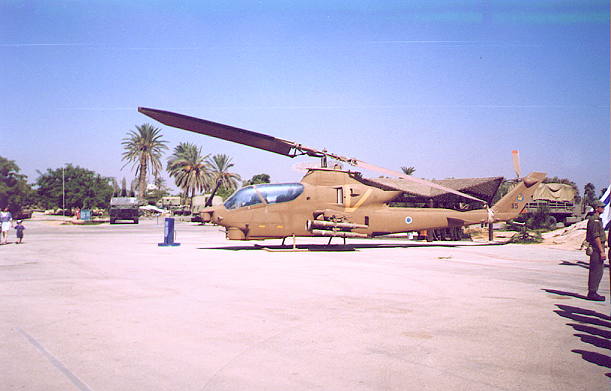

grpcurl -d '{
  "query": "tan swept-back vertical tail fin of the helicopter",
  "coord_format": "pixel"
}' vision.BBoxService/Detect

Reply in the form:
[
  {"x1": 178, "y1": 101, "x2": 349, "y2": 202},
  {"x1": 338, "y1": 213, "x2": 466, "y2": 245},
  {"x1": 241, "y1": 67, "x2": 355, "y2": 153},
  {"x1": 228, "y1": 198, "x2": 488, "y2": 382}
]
[{"x1": 492, "y1": 172, "x2": 545, "y2": 221}]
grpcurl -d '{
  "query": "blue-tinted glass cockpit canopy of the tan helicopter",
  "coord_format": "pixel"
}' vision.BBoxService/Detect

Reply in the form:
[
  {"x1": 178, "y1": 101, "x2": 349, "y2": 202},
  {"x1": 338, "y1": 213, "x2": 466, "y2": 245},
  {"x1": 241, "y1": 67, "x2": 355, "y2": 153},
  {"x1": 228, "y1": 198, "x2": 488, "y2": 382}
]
[{"x1": 224, "y1": 183, "x2": 303, "y2": 209}]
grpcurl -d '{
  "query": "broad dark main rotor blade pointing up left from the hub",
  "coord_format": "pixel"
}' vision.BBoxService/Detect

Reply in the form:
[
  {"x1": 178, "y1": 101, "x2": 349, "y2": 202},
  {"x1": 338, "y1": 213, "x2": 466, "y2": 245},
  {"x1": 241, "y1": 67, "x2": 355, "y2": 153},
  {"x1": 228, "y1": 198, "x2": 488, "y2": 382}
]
[{"x1": 138, "y1": 107, "x2": 296, "y2": 157}]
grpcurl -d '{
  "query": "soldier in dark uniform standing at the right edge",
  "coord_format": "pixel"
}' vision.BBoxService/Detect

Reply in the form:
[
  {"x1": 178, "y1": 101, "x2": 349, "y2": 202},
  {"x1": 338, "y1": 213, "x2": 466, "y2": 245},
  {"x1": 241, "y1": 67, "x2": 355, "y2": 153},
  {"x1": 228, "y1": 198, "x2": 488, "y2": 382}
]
[{"x1": 586, "y1": 200, "x2": 607, "y2": 301}]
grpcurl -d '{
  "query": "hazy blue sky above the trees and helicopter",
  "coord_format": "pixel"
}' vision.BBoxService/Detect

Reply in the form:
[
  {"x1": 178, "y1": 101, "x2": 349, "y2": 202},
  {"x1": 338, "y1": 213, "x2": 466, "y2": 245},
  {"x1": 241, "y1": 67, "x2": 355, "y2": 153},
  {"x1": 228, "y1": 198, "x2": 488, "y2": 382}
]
[{"x1": 0, "y1": 0, "x2": 610, "y2": 194}]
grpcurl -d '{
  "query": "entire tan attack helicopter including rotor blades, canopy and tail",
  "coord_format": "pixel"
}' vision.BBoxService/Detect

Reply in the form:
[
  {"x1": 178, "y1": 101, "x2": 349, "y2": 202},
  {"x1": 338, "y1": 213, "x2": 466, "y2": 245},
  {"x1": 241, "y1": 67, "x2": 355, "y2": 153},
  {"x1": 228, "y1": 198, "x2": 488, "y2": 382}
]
[{"x1": 138, "y1": 107, "x2": 545, "y2": 243}]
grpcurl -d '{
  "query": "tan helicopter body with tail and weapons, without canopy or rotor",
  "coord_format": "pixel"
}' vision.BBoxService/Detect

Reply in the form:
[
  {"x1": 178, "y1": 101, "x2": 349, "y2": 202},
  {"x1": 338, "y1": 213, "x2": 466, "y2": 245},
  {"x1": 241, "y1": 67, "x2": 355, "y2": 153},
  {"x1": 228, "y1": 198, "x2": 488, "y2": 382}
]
[{"x1": 202, "y1": 169, "x2": 544, "y2": 240}]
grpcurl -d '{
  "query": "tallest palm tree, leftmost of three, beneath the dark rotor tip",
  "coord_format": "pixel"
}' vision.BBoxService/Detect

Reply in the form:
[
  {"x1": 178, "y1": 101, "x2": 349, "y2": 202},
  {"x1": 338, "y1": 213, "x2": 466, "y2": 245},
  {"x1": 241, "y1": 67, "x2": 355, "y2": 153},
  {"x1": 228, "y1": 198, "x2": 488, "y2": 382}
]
[{"x1": 121, "y1": 124, "x2": 168, "y2": 198}]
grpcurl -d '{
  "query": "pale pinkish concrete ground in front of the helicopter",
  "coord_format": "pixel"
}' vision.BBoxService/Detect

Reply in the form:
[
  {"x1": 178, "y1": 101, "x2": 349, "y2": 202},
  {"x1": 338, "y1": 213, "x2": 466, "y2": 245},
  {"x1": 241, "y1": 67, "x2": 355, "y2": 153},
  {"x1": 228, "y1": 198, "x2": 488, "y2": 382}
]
[{"x1": 0, "y1": 219, "x2": 611, "y2": 391}]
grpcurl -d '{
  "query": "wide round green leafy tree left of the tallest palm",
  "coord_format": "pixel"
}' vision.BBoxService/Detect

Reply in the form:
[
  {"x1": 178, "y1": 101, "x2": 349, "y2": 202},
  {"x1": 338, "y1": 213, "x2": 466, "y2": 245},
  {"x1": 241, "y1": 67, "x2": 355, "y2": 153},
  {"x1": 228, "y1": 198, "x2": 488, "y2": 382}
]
[{"x1": 36, "y1": 164, "x2": 114, "y2": 209}]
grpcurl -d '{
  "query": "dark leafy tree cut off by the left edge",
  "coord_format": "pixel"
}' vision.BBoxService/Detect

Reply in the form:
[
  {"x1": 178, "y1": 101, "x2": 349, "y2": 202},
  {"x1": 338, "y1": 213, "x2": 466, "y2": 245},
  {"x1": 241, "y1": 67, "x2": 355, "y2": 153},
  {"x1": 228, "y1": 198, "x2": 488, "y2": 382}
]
[{"x1": 0, "y1": 156, "x2": 32, "y2": 213}]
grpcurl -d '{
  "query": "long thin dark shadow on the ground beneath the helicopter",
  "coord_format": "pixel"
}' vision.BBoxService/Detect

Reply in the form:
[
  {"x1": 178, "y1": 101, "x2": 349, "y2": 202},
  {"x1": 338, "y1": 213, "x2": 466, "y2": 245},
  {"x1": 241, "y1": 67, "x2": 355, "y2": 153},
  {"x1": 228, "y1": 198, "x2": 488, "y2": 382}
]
[{"x1": 198, "y1": 243, "x2": 474, "y2": 252}]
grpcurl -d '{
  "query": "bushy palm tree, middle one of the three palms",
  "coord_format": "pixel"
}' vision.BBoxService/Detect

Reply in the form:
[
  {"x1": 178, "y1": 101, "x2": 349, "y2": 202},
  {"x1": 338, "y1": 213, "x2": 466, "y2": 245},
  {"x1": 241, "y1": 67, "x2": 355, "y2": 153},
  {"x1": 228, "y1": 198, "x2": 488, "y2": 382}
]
[{"x1": 167, "y1": 143, "x2": 210, "y2": 202}]
